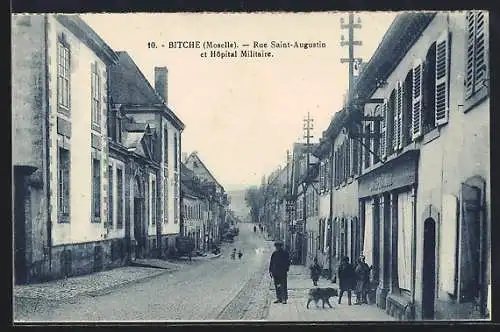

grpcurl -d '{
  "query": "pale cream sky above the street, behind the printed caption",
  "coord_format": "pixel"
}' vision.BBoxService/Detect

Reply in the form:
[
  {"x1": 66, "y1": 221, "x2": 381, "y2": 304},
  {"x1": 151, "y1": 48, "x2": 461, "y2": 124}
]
[{"x1": 82, "y1": 12, "x2": 397, "y2": 190}]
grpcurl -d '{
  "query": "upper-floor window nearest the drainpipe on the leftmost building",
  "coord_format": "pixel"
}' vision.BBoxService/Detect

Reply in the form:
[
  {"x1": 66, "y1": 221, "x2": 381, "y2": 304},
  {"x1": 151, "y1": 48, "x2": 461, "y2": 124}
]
[{"x1": 57, "y1": 35, "x2": 71, "y2": 110}]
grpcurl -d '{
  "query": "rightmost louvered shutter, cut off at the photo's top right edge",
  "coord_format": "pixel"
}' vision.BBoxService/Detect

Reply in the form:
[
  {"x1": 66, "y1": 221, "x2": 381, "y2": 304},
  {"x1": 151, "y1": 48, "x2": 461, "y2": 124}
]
[{"x1": 474, "y1": 11, "x2": 487, "y2": 91}]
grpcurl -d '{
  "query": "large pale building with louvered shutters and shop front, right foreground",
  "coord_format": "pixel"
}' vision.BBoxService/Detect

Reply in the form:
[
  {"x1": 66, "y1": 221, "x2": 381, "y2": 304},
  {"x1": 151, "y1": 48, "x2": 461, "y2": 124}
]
[{"x1": 318, "y1": 11, "x2": 491, "y2": 319}]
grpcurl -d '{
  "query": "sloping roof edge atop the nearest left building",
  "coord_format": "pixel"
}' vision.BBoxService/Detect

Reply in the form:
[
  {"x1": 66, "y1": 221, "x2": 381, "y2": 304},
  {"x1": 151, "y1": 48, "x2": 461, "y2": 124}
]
[{"x1": 55, "y1": 14, "x2": 118, "y2": 65}]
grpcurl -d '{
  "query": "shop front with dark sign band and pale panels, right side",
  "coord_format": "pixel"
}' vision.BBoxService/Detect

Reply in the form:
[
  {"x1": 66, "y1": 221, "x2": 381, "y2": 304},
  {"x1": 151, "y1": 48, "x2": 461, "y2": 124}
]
[{"x1": 358, "y1": 149, "x2": 419, "y2": 319}]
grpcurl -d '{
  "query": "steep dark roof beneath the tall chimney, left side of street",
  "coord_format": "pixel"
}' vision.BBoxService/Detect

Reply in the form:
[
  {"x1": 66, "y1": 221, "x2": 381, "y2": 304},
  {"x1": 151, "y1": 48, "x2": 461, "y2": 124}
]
[{"x1": 109, "y1": 51, "x2": 185, "y2": 130}]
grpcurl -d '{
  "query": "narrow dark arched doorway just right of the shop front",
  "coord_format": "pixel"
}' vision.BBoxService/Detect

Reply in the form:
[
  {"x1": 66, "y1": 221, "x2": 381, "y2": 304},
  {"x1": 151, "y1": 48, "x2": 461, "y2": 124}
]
[{"x1": 422, "y1": 218, "x2": 436, "y2": 319}]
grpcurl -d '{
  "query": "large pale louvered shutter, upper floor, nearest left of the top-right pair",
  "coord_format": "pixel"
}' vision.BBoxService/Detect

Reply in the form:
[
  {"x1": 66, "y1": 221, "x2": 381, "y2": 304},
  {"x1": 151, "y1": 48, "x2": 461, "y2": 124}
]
[{"x1": 434, "y1": 30, "x2": 450, "y2": 126}]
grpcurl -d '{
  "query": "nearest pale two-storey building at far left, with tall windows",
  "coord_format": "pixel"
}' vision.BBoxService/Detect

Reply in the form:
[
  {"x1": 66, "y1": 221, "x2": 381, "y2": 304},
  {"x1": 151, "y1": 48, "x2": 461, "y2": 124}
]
[{"x1": 12, "y1": 14, "x2": 117, "y2": 283}]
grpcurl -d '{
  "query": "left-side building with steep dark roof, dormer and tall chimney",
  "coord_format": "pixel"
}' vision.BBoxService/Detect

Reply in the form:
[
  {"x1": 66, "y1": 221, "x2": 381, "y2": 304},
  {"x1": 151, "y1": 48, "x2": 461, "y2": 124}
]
[{"x1": 109, "y1": 52, "x2": 184, "y2": 258}]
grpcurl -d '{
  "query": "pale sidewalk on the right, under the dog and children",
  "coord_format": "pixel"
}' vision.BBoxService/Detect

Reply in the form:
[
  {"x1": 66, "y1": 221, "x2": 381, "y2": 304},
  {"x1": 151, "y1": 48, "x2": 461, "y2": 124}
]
[{"x1": 267, "y1": 265, "x2": 395, "y2": 321}]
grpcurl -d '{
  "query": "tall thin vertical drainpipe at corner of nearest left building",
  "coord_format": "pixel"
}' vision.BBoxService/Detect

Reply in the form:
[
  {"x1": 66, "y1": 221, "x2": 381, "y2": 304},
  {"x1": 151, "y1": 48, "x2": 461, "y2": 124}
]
[{"x1": 43, "y1": 14, "x2": 52, "y2": 271}]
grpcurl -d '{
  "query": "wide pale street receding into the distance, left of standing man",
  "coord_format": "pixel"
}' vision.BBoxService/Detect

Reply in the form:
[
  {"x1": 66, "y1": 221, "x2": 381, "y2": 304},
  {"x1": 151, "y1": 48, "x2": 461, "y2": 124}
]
[{"x1": 14, "y1": 224, "x2": 272, "y2": 322}]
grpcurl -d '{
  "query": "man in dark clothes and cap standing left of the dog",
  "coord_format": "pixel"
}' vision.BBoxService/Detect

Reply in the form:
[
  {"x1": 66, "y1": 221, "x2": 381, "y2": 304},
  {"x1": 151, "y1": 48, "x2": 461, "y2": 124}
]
[{"x1": 269, "y1": 241, "x2": 290, "y2": 304}]
